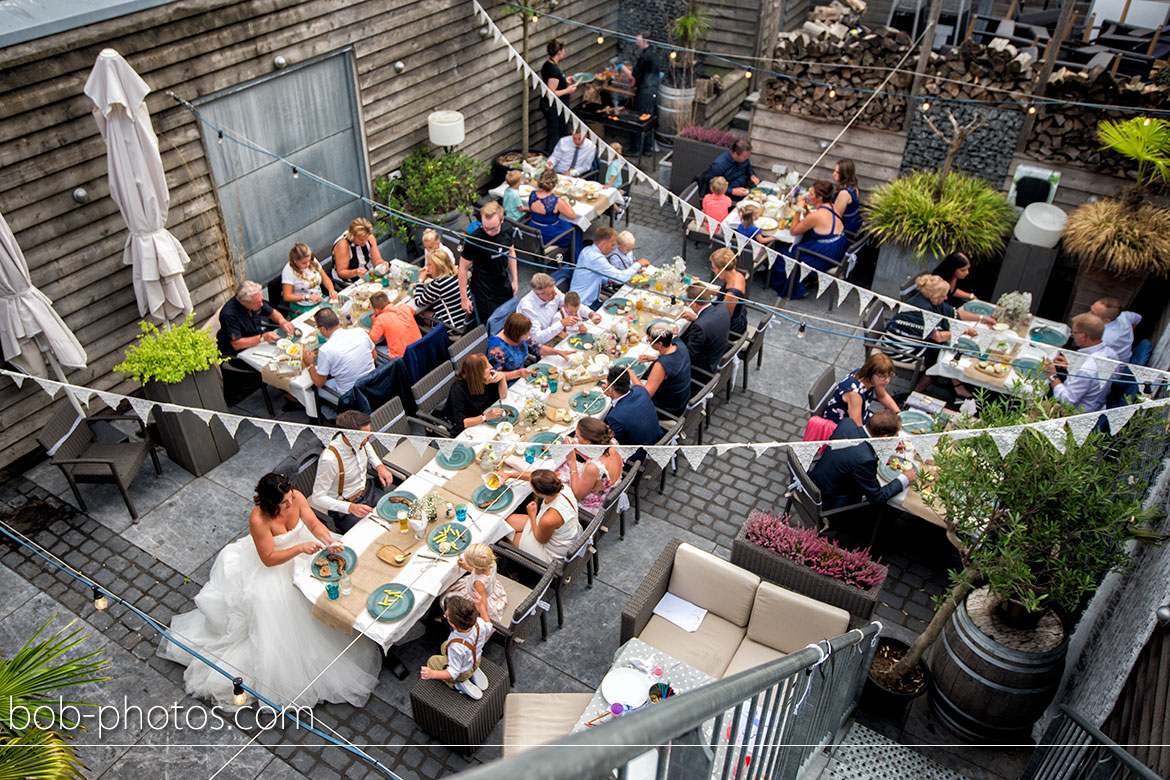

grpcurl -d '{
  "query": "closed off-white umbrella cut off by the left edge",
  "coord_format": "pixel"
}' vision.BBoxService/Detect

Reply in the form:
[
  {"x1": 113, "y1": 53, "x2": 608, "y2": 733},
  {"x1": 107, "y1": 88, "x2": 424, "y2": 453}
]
[{"x1": 0, "y1": 206, "x2": 87, "y2": 381}]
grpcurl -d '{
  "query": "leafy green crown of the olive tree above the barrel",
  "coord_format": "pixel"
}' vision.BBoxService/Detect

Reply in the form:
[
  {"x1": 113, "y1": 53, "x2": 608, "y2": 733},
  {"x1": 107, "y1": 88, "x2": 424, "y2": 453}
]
[{"x1": 928, "y1": 382, "x2": 1166, "y2": 612}]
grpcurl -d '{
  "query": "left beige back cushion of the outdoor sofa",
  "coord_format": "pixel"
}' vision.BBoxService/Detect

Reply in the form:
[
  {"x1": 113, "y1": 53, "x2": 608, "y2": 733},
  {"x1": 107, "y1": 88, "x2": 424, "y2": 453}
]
[{"x1": 667, "y1": 543, "x2": 759, "y2": 626}]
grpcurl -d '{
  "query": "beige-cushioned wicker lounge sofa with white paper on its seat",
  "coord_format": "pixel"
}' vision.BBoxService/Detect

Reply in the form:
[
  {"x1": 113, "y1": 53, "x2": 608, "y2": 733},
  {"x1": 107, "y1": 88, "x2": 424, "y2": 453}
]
[{"x1": 621, "y1": 539, "x2": 849, "y2": 678}]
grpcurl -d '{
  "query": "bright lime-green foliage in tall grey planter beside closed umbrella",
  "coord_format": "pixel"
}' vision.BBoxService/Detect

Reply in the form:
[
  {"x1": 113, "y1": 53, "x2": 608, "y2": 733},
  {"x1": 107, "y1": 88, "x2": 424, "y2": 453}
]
[{"x1": 113, "y1": 316, "x2": 226, "y2": 385}]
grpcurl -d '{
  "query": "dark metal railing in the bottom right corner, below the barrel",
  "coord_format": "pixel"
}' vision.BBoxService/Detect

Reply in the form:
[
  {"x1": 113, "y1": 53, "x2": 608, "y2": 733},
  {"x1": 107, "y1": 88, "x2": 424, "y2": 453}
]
[{"x1": 1020, "y1": 705, "x2": 1161, "y2": 780}]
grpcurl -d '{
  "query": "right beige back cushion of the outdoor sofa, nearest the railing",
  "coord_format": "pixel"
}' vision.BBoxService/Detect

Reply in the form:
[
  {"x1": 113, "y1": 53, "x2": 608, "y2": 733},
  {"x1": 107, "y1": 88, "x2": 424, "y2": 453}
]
[{"x1": 748, "y1": 582, "x2": 849, "y2": 654}]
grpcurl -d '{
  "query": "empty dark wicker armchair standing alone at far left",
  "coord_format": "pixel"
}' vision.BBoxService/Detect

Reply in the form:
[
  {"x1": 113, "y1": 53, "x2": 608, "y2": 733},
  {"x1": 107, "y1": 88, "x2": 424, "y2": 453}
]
[{"x1": 36, "y1": 403, "x2": 163, "y2": 522}]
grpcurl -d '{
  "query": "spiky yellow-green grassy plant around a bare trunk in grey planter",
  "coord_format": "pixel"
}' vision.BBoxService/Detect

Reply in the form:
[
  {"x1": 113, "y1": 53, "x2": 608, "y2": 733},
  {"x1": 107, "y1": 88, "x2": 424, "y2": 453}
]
[{"x1": 865, "y1": 171, "x2": 1016, "y2": 262}]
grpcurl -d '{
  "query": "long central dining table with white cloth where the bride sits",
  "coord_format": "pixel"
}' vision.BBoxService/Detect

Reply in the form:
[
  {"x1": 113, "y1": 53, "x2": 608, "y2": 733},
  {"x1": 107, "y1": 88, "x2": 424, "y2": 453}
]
[{"x1": 294, "y1": 271, "x2": 688, "y2": 651}]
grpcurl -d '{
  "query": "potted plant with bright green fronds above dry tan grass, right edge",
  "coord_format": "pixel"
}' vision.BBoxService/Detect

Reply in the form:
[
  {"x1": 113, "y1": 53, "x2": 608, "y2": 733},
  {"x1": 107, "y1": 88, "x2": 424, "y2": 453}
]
[{"x1": 1061, "y1": 117, "x2": 1170, "y2": 311}]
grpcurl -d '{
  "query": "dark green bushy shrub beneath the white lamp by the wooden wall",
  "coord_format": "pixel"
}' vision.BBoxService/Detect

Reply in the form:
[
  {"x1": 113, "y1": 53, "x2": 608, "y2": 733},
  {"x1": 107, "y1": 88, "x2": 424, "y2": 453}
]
[{"x1": 373, "y1": 146, "x2": 488, "y2": 241}]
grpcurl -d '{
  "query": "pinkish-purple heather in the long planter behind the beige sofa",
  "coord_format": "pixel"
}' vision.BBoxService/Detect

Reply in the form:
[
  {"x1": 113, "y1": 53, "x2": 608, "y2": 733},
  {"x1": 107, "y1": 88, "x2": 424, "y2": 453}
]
[{"x1": 744, "y1": 510, "x2": 886, "y2": 591}]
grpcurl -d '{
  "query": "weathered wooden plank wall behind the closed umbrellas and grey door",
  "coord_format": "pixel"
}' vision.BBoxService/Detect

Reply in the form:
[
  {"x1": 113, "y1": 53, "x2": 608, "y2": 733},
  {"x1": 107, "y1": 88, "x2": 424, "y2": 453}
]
[{"x1": 0, "y1": 0, "x2": 618, "y2": 467}]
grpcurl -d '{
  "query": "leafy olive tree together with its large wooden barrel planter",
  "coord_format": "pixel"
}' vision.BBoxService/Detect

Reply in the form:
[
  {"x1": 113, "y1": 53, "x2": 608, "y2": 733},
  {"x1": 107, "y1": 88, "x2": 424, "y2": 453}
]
[{"x1": 870, "y1": 382, "x2": 1165, "y2": 743}]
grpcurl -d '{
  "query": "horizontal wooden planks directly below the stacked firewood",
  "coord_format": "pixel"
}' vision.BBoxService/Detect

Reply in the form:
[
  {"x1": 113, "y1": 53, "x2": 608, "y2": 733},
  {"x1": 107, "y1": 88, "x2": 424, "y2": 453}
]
[{"x1": 749, "y1": 104, "x2": 906, "y2": 191}]
